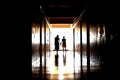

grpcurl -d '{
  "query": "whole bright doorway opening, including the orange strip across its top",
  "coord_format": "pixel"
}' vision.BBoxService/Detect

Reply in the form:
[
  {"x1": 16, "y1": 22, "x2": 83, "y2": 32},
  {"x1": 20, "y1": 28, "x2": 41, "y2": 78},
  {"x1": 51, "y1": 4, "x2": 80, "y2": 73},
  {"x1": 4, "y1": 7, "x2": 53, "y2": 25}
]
[{"x1": 50, "y1": 24, "x2": 73, "y2": 50}]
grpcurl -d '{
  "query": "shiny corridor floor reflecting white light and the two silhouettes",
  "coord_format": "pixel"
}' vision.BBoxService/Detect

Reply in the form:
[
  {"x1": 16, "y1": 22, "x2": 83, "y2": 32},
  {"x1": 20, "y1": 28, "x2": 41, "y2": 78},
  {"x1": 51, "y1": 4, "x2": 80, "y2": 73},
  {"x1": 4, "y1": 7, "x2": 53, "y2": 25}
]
[{"x1": 32, "y1": 51, "x2": 100, "y2": 80}]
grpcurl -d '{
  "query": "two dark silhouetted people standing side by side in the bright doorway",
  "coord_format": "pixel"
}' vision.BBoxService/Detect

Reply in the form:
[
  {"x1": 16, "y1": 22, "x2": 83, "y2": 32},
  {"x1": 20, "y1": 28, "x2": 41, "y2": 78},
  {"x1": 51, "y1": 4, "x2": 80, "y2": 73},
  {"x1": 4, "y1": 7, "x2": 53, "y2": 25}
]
[{"x1": 54, "y1": 35, "x2": 66, "y2": 51}]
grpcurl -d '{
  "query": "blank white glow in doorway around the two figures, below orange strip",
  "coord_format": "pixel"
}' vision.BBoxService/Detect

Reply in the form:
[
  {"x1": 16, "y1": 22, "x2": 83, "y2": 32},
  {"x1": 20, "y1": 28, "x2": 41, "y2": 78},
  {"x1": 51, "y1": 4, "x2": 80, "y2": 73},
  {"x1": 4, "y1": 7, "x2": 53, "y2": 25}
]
[{"x1": 50, "y1": 25, "x2": 73, "y2": 50}]
